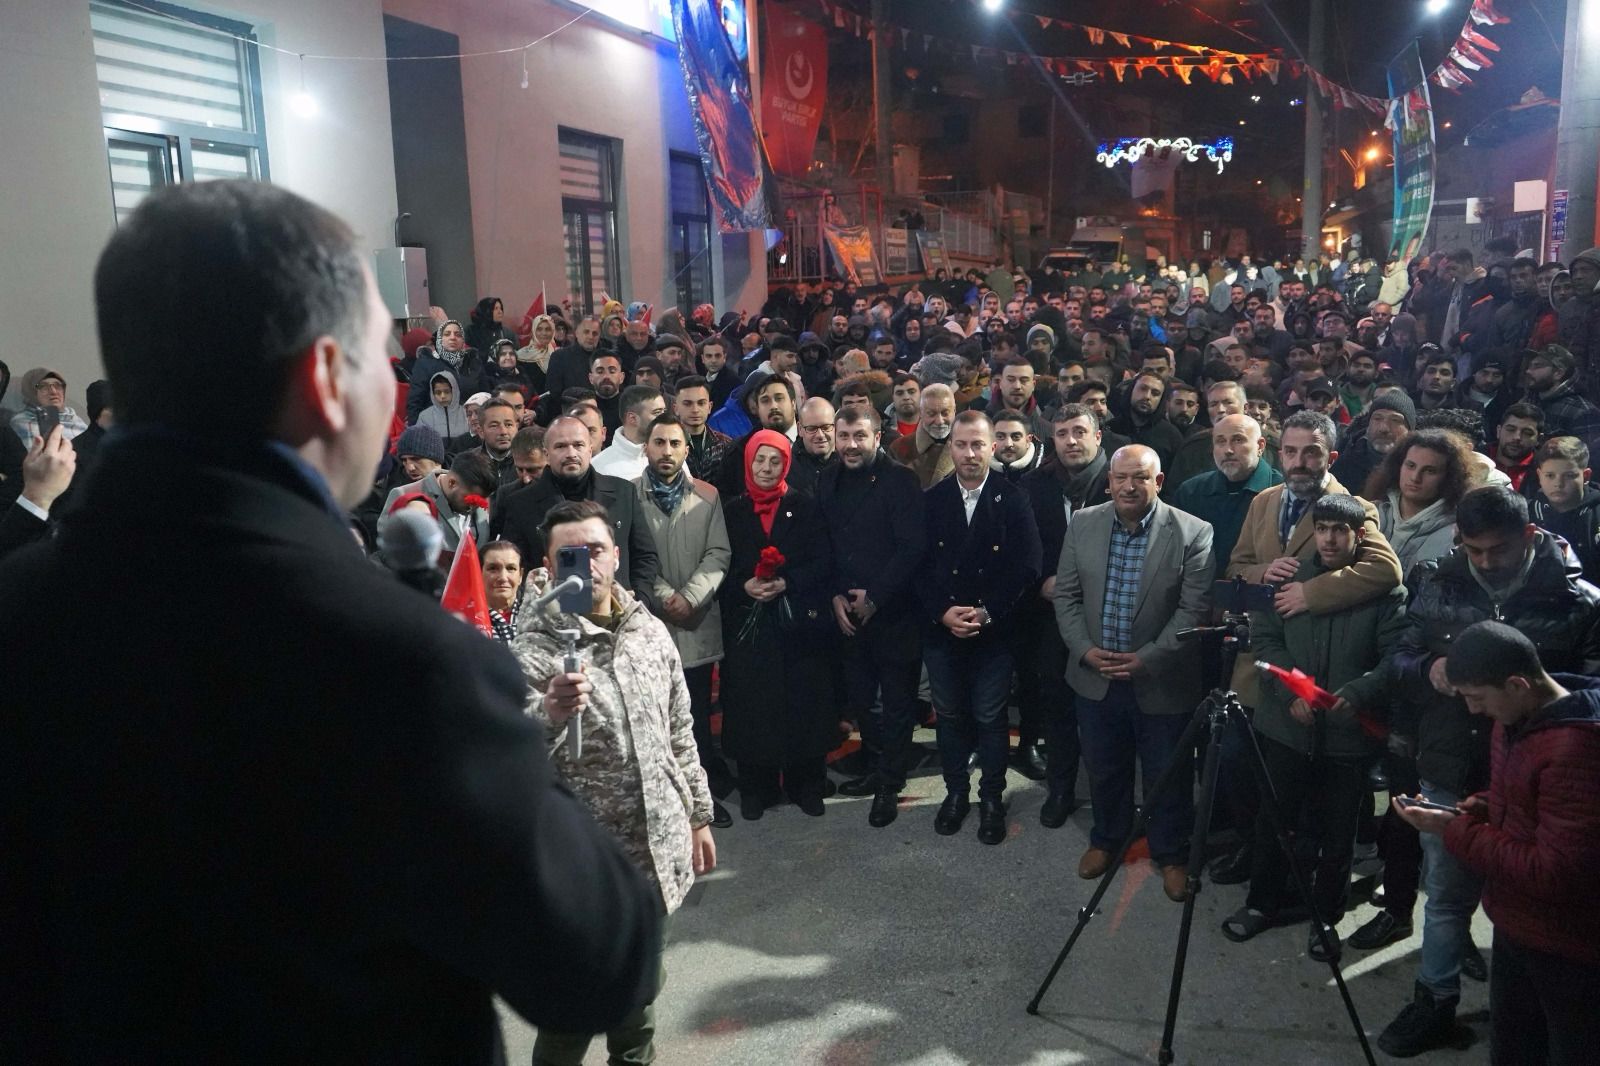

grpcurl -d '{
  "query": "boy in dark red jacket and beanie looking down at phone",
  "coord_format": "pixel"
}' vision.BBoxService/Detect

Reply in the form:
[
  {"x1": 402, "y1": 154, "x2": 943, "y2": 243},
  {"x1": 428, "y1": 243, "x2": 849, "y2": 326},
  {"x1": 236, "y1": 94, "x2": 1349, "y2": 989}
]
[{"x1": 1395, "y1": 621, "x2": 1600, "y2": 1066}]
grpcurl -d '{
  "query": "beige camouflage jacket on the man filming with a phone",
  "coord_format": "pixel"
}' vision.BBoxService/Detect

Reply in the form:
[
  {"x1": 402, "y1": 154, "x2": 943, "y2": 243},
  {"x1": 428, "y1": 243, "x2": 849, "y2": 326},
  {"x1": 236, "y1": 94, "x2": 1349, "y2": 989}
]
[{"x1": 510, "y1": 570, "x2": 712, "y2": 914}]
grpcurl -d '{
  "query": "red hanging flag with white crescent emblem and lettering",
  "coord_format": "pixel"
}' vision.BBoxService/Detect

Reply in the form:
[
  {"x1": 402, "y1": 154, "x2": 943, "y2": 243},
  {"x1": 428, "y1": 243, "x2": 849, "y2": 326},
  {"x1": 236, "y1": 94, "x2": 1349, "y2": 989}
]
[{"x1": 762, "y1": 3, "x2": 827, "y2": 176}]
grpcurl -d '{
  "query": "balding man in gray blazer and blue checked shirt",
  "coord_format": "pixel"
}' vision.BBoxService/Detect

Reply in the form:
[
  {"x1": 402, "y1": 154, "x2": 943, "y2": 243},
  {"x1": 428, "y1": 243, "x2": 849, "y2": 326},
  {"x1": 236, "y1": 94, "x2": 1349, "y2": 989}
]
[{"x1": 1056, "y1": 445, "x2": 1216, "y2": 901}]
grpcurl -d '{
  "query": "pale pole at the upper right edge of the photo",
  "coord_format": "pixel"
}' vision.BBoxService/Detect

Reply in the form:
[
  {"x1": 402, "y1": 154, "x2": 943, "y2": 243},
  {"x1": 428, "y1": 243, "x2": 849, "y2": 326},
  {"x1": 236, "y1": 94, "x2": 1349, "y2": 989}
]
[{"x1": 1539, "y1": 0, "x2": 1600, "y2": 262}]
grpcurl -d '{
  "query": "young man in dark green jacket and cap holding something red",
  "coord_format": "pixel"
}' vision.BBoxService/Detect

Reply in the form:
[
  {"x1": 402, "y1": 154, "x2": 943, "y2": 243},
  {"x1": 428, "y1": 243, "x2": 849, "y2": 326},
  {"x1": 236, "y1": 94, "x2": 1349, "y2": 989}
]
[{"x1": 1222, "y1": 493, "x2": 1405, "y2": 960}]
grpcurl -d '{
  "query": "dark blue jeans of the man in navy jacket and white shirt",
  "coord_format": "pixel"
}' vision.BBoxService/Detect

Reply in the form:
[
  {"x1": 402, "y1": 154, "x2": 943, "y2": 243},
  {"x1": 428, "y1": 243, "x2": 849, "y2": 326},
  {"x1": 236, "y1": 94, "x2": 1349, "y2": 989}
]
[{"x1": 923, "y1": 634, "x2": 1014, "y2": 800}]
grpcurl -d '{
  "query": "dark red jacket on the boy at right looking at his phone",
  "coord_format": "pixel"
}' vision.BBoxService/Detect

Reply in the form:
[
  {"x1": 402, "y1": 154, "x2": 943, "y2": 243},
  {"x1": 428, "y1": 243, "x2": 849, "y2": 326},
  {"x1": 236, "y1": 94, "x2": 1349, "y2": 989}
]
[{"x1": 1445, "y1": 674, "x2": 1600, "y2": 967}]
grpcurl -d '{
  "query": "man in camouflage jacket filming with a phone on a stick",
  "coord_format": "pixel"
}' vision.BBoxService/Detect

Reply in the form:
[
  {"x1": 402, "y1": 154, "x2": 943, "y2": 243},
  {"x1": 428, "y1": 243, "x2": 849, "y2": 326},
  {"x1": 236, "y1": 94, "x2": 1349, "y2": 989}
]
[{"x1": 510, "y1": 499, "x2": 717, "y2": 1066}]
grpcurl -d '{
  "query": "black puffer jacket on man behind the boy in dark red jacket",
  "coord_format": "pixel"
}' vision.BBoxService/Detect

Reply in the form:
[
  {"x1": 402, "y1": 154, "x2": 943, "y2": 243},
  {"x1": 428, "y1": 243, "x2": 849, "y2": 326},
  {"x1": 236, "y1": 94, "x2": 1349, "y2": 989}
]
[{"x1": 1390, "y1": 531, "x2": 1600, "y2": 795}]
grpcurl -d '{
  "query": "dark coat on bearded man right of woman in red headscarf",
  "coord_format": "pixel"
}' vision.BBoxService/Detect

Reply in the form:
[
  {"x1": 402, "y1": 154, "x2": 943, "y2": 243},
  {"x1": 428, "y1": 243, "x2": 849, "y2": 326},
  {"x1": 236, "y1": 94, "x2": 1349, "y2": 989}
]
[{"x1": 816, "y1": 451, "x2": 928, "y2": 656}]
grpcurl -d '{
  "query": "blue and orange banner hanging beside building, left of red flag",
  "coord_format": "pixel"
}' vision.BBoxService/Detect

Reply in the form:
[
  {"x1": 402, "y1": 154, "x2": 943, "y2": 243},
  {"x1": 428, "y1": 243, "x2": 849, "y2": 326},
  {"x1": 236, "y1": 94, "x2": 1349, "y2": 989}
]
[{"x1": 672, "y1": 0, "x2": 776, "y2": 234}]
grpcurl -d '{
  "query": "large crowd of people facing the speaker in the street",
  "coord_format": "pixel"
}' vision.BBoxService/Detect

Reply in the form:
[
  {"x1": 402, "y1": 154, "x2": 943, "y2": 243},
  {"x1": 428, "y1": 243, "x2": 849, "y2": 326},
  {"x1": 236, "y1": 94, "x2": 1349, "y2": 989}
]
[{"x1": 9, "y1": 182, "x2": 1600, "y2": 1063}]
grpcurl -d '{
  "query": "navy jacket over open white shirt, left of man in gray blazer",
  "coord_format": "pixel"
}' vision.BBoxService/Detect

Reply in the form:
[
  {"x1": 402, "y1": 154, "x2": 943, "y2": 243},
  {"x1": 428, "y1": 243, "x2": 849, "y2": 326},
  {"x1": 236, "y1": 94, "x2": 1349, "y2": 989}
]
[{"x1": 917, "y1": 472, "x2": 1040, "y2": 639}]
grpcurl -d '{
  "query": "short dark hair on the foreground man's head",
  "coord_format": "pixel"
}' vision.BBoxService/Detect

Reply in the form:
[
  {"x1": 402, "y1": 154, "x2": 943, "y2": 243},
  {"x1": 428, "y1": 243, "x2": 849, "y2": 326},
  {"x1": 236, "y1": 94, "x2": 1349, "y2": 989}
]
[{"x1": 94, "y1": 181, "x2": 368, "y2": 439}]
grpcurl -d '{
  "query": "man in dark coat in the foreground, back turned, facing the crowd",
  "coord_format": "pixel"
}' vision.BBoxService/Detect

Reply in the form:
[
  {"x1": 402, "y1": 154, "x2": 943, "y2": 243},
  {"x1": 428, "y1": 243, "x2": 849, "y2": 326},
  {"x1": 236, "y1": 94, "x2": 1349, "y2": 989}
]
[{"x1": 0, "y1": 181, "x2": 661, "y2": 1063}]
